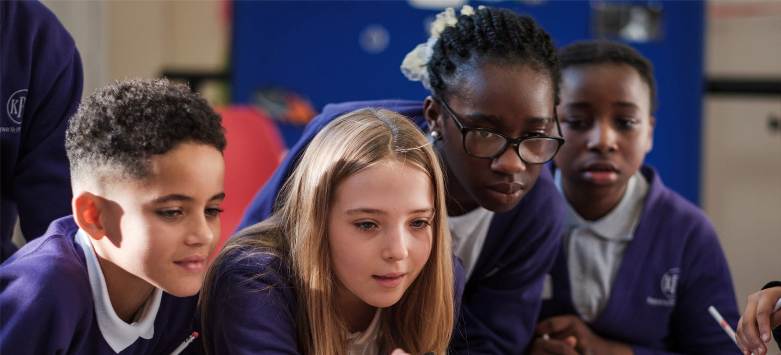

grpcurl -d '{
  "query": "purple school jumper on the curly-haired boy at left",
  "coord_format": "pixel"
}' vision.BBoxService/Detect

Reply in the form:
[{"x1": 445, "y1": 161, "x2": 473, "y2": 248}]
[{"x1": 0, "y1": 216, "x2": 198, "y2": 355}]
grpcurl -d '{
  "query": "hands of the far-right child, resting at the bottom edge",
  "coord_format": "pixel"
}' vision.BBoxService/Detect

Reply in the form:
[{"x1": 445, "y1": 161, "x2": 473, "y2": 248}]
[{"x1": 535, "y1": 315, "x2": 634, "y2": 355}]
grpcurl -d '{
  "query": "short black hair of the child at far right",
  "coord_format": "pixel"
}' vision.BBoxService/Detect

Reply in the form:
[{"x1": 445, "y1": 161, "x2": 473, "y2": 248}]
[{"x1": 559, "y1": 40, "x2": 658, "y2": 111}]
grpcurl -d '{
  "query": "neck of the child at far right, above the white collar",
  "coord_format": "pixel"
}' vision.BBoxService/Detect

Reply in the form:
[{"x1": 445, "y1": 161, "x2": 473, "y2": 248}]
[{"x1": 562, "y1": 180, "x2": 626, "y2": 221}]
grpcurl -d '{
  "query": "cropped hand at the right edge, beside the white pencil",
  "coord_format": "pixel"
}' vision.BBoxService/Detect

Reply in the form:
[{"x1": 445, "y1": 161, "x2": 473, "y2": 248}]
[{"x1": 737, "y1": 287, "x2": 781, "y2": 355}]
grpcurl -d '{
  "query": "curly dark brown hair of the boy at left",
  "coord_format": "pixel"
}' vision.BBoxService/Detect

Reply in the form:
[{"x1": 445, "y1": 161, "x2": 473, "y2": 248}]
[{"x1": 65, "y1": 79, "x2": 226, "y2": 179}]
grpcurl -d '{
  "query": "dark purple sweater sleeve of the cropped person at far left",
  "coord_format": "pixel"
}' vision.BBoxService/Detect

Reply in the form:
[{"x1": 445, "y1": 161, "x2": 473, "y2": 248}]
[{"x1": 10, "y1": 2, "x2": 83, "y2": 246}]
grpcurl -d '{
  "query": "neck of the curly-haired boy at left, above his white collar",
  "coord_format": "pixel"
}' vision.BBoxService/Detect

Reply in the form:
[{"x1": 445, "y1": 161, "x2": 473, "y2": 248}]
[{"x1": 96, "y1": 249, "x2": 154, "y2": 323}]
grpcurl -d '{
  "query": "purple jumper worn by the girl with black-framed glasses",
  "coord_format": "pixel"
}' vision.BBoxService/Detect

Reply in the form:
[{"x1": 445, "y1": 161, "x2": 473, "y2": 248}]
[{"x1": 235, "y1": 100, "x2": 565, "y2": 354}]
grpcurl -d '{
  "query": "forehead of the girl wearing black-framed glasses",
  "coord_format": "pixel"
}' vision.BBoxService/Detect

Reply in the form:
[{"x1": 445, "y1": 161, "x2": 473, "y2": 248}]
[{"x1": 450, "y1": 62, "x2": 554, "y2": 124}]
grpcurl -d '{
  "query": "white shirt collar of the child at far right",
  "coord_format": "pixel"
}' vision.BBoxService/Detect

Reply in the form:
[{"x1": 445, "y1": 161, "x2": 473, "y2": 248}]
[{"x1": 554, "y1": 169, "x2": 648, "y2": 241}]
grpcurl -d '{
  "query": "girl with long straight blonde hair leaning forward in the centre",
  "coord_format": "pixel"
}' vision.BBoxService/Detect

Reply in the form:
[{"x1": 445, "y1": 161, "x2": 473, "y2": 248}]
[{"x1": 201, "y1": 109, "x2": 460, "y2": 355}]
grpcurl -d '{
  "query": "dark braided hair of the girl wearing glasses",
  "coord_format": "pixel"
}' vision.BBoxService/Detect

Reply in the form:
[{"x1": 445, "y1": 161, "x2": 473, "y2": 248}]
[{"x1": 428, "y1": 7, "x2": 560, "y2": 104}]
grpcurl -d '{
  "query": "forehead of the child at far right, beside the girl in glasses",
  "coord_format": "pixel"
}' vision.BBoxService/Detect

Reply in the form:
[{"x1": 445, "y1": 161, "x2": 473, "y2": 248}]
[{"x1": 561, "y1": 63, "x2": 650, "y2": 106}]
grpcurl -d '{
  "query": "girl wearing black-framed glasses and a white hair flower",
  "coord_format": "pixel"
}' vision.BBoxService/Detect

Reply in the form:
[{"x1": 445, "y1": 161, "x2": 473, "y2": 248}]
[{"x1": 242, "y1": 6, "x2": 564, "y2": 354}]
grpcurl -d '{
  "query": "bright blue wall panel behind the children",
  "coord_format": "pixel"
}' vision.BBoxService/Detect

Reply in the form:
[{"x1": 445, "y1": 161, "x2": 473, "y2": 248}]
[{"x1": 231, "y1": 1, "x2": 704, "y2": 203}]
